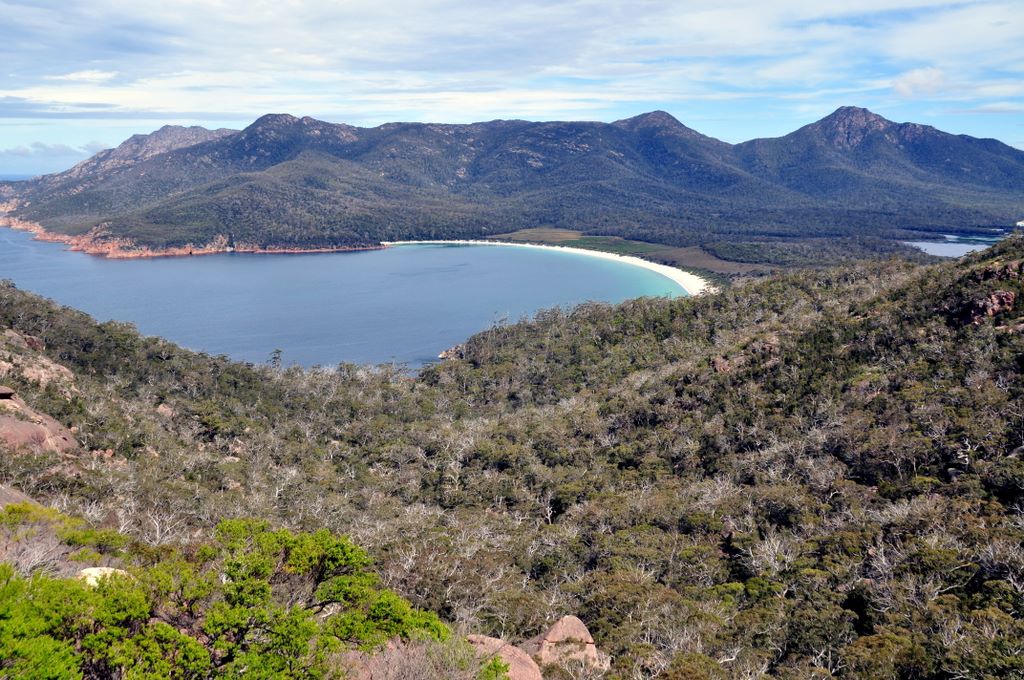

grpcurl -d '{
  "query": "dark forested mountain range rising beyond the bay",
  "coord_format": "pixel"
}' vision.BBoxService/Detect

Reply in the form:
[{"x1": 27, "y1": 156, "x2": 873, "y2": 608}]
[{"x1": 0, "y1": 107, "x2": 1024, "y2": 262}]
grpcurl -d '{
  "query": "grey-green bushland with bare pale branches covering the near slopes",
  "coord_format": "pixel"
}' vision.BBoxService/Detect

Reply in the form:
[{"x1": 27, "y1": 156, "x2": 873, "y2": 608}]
[{"x1": 0, "y1": 237, "x2": 1024, "y2": 679}]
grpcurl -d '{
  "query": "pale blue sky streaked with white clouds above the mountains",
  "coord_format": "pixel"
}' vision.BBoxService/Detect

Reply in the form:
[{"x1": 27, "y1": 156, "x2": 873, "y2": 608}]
[{"x1": 0, "y1": 0, "x2": 1024, "y2": 176}]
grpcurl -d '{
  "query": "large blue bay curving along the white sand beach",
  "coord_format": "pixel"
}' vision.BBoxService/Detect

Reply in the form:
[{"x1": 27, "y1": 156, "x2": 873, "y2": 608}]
[{"x1": 0, "y1": 228, "x2": 684, "y2": 367}]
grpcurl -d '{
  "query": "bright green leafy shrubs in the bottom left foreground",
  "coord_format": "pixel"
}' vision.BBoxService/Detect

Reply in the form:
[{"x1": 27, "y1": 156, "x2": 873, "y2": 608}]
[{"x1": 0, "y1": 503, "x2": 501, "y2": 680}]
